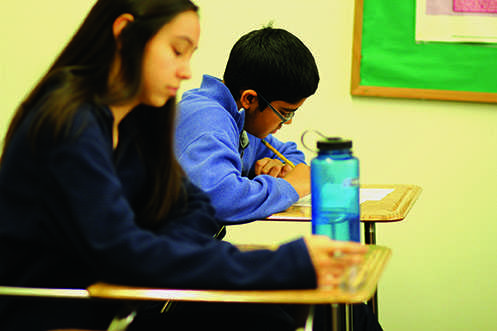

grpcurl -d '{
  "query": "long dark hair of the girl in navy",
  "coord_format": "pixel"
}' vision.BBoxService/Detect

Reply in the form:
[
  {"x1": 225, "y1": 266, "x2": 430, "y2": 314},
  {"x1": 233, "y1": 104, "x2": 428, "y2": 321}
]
[{"x1": 3, "y1": 0, "x2": 198, "y2": 226}]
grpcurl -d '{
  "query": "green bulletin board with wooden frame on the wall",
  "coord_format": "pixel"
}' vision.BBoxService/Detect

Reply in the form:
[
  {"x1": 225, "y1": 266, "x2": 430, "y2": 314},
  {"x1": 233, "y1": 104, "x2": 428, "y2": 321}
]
[{"x1": 351, "y1": 0, "x2": 497, "y2": 103}]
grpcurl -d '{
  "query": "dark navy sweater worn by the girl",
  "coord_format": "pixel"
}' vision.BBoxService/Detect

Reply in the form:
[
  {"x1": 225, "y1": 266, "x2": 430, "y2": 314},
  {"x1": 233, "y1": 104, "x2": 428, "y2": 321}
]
[{"x1": 0, "y1": 104, "x2": 316, "y2": 331}]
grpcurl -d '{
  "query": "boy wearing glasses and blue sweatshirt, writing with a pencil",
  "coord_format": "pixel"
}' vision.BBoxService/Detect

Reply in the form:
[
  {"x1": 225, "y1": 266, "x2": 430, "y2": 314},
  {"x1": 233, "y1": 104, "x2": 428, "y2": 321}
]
[{"x1": 175, "y1": 27, "x2": 319, "y2": 223}]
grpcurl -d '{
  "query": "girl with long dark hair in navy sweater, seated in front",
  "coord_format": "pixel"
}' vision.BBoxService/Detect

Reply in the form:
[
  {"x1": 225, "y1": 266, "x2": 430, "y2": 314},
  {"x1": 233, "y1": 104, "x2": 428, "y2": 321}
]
[{"x1": 0, "y1": 0, "x2": 372, "y2": 331}]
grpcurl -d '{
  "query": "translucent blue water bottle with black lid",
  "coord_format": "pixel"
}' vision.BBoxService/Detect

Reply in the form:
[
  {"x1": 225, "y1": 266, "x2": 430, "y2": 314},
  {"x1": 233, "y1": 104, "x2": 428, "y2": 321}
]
[{"x1": 311, "y1": 138, "x2": 361, "y2": 242}]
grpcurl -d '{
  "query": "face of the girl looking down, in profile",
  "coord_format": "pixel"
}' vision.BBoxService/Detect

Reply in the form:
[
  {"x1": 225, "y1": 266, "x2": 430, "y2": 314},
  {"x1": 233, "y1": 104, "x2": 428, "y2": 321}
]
[{"x1": 138, "y1": 11, "x2": 200, "y2": 107}]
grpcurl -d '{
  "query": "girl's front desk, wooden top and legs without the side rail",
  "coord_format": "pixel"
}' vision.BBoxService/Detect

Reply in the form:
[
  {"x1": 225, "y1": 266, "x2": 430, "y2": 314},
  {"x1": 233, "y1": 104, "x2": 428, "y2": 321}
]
[{"x1": 87, "y1": 245, "x2": 391, "y2": 331}]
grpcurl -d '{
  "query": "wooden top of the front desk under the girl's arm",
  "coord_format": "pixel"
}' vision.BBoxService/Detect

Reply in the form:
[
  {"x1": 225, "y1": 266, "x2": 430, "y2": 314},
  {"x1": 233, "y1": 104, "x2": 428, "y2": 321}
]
[{"x1": 87, "y1": 246, "x2": 391, "y2": 304}]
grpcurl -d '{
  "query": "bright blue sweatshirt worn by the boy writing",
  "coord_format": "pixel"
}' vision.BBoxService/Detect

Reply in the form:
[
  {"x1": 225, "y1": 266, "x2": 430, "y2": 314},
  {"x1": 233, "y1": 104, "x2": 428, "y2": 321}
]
[{"x1": 176, "y1": 75, "x2": 304, "y2": 224}]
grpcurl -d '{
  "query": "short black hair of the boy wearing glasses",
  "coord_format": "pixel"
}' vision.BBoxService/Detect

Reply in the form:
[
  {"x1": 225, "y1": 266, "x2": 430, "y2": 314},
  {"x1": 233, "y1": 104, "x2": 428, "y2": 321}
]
[{"x1": 223, "y1": 27, "x2": 319, "y2": 108}]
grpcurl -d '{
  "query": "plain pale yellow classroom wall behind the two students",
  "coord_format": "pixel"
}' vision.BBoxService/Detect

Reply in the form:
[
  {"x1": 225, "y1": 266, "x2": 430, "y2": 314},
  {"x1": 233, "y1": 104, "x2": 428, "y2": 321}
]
[{"x1": 0, "y1": 0, "x2": 497, "y2": 331}]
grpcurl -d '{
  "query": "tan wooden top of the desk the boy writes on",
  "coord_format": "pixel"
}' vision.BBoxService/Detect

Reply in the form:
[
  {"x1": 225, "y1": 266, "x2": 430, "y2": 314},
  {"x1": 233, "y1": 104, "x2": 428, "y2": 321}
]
[{"x1": 267, "y1": 184, "x2": 422, "y2": 222}]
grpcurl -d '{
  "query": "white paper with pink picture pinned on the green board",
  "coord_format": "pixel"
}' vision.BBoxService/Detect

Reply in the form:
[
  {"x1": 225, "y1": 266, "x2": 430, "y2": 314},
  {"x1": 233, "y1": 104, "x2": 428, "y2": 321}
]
[{"x1": 416, "y1": 0, "x2": 497, "y2": 43}]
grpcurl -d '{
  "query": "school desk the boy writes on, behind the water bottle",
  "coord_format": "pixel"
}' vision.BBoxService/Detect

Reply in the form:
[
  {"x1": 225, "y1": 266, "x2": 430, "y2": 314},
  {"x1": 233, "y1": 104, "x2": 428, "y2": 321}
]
[{"x1": 266, "y1": 184, "x2": 421, "y2": 316}]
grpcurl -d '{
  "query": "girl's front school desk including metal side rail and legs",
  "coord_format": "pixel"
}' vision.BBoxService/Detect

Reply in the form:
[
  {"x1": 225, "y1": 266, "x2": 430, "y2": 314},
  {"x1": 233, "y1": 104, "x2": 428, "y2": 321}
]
[{"x1": 0, "y1": 245, "x2": 391, "y2": 331}]
